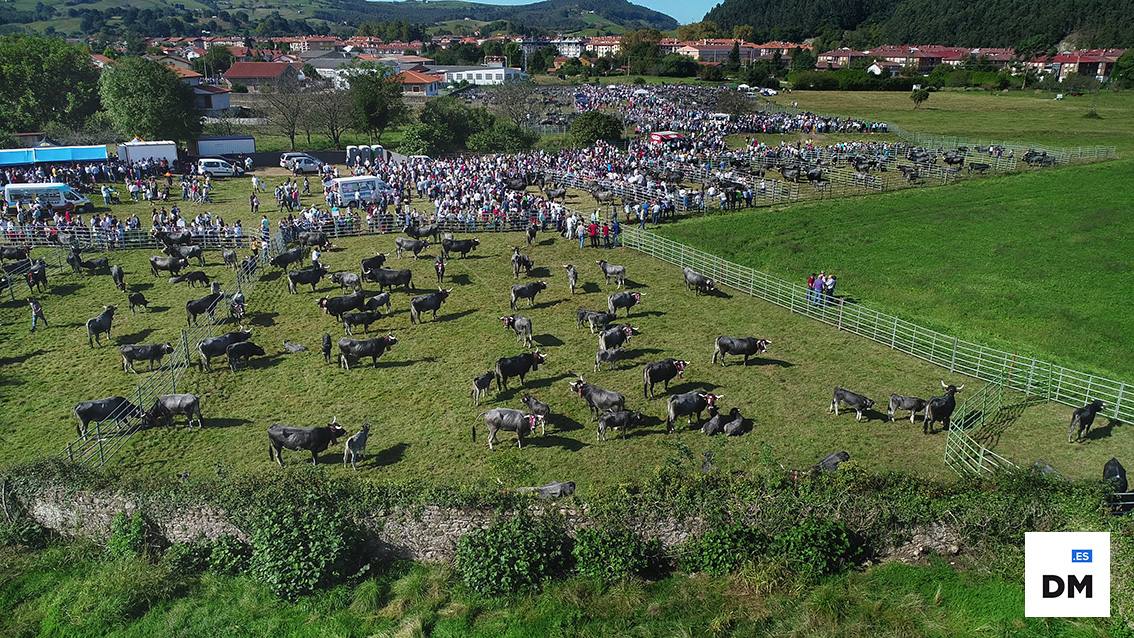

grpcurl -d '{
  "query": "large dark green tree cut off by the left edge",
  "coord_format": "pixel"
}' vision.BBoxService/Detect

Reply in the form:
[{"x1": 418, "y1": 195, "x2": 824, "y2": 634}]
[{"x1": 0, "y1": 35, "x2": 99, "y2": 131}]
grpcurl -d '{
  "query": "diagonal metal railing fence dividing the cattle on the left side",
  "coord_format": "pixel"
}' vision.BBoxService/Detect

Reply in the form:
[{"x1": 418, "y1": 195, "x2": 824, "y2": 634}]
[{"x1": 64, "y1": 232, "x2": 281, "y2": 466}]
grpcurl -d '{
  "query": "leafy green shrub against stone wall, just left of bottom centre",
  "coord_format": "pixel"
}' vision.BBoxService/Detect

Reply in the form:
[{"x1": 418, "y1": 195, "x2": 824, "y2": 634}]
[{"x1": 455, "y1": 513, "x2": 570, "y2": 595}]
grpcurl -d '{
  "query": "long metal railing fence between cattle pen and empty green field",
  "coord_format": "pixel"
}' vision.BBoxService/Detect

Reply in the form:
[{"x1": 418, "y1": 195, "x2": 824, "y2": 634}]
[{"x1": 621, "y1": 227, "x2": 1134, "y2": 471}]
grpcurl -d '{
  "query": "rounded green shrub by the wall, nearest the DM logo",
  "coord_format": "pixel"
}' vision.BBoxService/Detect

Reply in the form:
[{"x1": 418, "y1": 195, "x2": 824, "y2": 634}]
[{"x1": 770, "y1": 518, "x2": 862, "y2": 577}]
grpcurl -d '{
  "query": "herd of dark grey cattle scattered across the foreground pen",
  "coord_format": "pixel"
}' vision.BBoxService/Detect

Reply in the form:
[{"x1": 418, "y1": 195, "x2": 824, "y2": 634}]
[{"x1": 0, "y1": 226, "x2": 1102, "y2": 466}]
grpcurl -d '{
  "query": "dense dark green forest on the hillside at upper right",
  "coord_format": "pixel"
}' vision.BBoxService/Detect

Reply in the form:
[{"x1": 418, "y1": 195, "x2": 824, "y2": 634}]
[{"x1": 704, "y1": 0, "x2": 1134, "y2": 48}]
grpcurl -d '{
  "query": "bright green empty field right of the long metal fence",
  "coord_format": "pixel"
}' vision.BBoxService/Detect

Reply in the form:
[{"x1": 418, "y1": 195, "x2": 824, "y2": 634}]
[{"x1": 661, "y1": 160, "x2": 1134, "y2": 380}]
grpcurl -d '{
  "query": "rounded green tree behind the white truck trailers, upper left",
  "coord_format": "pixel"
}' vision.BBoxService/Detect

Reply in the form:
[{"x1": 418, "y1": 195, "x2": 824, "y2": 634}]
[{"x1": 99, "y1": 58, "x2": 201, "y2": 142}]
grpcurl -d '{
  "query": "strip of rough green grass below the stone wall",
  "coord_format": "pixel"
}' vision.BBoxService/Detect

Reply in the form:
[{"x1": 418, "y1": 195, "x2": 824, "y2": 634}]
[{"x1": 0, "y1": 545, "x2": 1111, "y2": 638}]
